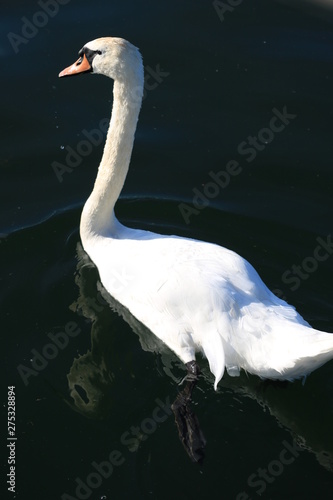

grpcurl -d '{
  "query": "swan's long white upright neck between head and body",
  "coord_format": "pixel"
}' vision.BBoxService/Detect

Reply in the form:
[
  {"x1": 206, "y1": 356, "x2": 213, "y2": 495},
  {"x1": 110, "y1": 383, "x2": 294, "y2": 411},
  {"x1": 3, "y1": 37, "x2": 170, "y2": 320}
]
[{"x1": 80, "y1": 71, "x2": 143, "y2": 241}]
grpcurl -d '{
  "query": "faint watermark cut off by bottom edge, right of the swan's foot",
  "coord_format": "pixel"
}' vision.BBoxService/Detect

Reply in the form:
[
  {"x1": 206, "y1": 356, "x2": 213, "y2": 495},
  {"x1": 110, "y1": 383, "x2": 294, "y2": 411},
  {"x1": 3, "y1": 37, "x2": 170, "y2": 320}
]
[{"x1": 236, "y1": 441, "x2": 303, "y2": 500}]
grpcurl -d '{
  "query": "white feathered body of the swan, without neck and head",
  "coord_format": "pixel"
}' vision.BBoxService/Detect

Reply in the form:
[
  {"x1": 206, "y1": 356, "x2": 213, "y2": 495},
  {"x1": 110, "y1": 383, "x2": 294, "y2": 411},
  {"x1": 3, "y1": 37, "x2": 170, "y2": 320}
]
[{"x1": 82, "y1": 225, "x2": 333, "y2": 387}]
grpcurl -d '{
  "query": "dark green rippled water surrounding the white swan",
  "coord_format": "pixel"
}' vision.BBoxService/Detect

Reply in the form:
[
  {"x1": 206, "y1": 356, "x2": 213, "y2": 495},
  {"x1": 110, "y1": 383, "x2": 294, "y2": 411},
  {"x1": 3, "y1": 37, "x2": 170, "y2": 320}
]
[{"x1": 0, "y1": 0, "x2": 333, "y2": 500}]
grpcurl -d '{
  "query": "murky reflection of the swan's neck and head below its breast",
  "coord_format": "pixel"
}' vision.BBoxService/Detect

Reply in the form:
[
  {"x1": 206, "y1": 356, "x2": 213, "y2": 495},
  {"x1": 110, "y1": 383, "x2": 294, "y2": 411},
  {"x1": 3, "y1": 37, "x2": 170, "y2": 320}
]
[{"x1": 67, "y1": 245, "x2": 184, "y2": 419}]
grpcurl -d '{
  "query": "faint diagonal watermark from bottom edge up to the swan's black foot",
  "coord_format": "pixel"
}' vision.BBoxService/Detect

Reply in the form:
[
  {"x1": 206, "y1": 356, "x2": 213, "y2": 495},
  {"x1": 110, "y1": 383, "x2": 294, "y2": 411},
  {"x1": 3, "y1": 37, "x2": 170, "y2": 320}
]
[{"x1": 61, "y1": 397, "x2": 172, "y2": 500}]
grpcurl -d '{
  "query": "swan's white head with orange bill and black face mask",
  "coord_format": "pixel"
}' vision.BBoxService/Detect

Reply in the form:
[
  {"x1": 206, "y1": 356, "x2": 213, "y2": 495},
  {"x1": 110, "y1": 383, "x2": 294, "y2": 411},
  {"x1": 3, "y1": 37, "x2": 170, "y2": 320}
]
[{"x1": 59, "y1": 37, "x2": 143, "y2": 81}]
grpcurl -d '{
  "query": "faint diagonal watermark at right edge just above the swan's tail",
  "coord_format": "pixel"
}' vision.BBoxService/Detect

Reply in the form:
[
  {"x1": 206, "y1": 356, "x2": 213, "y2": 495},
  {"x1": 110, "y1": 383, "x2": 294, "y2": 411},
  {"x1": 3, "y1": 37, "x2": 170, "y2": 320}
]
[{"x1": 272, "y1": 234, "x2": 333, "y2": 299}]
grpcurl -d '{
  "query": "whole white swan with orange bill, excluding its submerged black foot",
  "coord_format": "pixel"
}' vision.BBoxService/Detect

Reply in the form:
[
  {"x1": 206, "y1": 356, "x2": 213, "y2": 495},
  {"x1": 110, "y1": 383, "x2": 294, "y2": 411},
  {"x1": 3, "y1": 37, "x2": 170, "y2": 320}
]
[{"x1": 59, "y1": 38, "x2": 333, "y2": 389}]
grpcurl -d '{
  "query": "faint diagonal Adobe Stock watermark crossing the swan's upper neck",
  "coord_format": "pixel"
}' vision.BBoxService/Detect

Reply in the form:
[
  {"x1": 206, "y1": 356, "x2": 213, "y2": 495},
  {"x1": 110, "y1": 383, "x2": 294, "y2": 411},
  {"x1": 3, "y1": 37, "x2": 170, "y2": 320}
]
[{"x1": 51, "y1": 64, "x2": 170, "y2": 183}]
